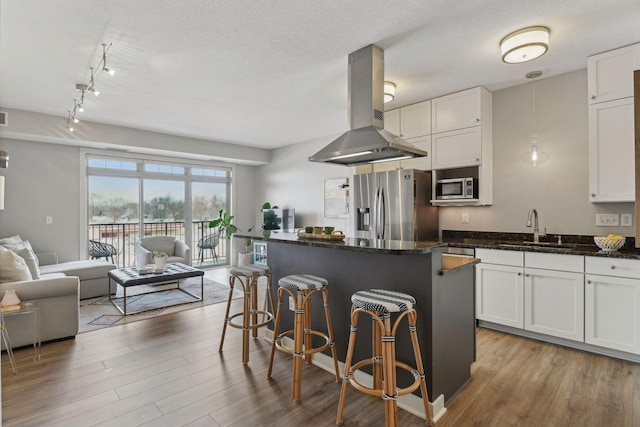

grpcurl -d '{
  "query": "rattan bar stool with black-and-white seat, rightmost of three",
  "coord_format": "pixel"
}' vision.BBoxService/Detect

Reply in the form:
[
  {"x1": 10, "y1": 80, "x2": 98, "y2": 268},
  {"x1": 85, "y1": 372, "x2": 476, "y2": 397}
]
[{"x1": 336, "y1": 289, "x2": 433, "y2": 427}]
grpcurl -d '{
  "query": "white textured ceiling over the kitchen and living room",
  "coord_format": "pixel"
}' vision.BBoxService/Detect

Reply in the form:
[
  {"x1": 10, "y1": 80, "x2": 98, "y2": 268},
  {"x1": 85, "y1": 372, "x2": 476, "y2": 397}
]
[{"x1": 0, "y1": 0, "x2": 640, "y2": 148}]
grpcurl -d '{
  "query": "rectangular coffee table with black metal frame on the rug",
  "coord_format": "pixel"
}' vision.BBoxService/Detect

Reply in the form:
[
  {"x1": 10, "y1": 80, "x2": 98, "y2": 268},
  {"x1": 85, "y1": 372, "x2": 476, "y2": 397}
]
[{"x1": 108, "y1": 262, "x2": 204, "y2": 316}]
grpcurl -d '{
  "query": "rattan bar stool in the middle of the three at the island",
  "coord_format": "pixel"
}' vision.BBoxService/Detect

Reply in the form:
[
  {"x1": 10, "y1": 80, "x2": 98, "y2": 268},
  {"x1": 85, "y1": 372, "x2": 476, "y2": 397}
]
[{"x1": 267, "y1": 274, "x2": 340, "y2": 402}]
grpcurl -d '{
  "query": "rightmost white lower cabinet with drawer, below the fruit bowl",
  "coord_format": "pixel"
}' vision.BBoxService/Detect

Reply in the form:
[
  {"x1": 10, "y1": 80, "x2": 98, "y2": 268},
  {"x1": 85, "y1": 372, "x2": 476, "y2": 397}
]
[{"x1": 585, "y1": 257, "x2": 640, "y2": 354}]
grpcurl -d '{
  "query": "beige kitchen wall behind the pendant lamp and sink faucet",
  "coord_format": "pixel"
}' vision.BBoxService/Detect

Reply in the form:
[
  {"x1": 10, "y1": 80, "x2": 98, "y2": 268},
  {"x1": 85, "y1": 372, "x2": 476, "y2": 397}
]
[{"x1": 440, "y1": 69, "x2": 634, "y2": 236}]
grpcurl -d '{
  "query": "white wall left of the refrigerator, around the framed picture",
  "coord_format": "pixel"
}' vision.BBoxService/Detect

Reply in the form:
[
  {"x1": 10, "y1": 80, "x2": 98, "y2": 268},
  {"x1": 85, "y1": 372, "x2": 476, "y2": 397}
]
[{"x1": 256, "y1": 135, "x2": 355, "y2": 235}]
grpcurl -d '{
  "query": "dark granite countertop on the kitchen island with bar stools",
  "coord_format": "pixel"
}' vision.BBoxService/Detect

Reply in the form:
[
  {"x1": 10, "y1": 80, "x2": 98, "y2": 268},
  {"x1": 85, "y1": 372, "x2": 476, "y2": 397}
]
[{"x1": 234, "y1": 231, "x2": 447, "y2": 255}]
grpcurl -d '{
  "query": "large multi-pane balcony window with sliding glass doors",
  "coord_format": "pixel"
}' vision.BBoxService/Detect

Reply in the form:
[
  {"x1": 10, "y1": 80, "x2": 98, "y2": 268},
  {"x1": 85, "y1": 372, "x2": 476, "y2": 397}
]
[{"x1": 87, "y1": 154, "x2": 231, "y2": 267}]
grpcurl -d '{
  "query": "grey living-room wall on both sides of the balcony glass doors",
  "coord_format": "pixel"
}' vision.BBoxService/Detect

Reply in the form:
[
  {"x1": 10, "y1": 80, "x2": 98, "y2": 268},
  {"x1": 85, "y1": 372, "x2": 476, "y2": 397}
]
[{"x1": 0, "y1": 138, "x2": 256, "y2": 261}]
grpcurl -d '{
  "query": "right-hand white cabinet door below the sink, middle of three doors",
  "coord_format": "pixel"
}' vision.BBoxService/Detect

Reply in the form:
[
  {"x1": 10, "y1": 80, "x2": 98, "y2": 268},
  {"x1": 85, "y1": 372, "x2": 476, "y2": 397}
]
[{"x1": 524, "y1": 270, "x2": 584, "y2": 341}]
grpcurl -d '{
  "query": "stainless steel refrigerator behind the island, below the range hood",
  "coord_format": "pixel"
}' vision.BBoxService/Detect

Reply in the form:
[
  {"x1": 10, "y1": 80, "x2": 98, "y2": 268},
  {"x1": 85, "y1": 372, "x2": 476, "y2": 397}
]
[{"x1": 353, "y1": 169, "x2": 438, "y2": 241}]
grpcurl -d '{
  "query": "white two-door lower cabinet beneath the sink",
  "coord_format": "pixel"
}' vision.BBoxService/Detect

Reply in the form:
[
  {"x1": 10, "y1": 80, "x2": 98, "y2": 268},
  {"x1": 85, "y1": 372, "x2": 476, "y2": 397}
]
[{"x1": 476, "y1": 249, "x2": 584, "y2": 341}]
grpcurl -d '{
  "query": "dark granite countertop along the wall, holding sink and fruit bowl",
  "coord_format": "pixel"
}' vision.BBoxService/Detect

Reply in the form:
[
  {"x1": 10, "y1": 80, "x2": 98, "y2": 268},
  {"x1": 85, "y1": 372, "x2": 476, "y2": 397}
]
[{"x1": 442, "y1": 230, "x2": 640, "y2": 259}]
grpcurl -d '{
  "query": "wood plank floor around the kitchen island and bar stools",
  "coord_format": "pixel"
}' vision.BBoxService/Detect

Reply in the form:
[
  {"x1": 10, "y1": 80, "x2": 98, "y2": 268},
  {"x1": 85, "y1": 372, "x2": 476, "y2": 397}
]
[{"x1": 2, "y1": 272, "x2": 640, "y2": 427}]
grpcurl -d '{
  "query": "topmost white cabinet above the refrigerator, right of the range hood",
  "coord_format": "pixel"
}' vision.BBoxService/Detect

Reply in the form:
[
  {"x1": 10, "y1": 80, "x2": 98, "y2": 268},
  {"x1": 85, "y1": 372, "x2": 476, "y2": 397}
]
[{"x1": 384, "y1": 100, "x2": 431, "y2": 139}]
